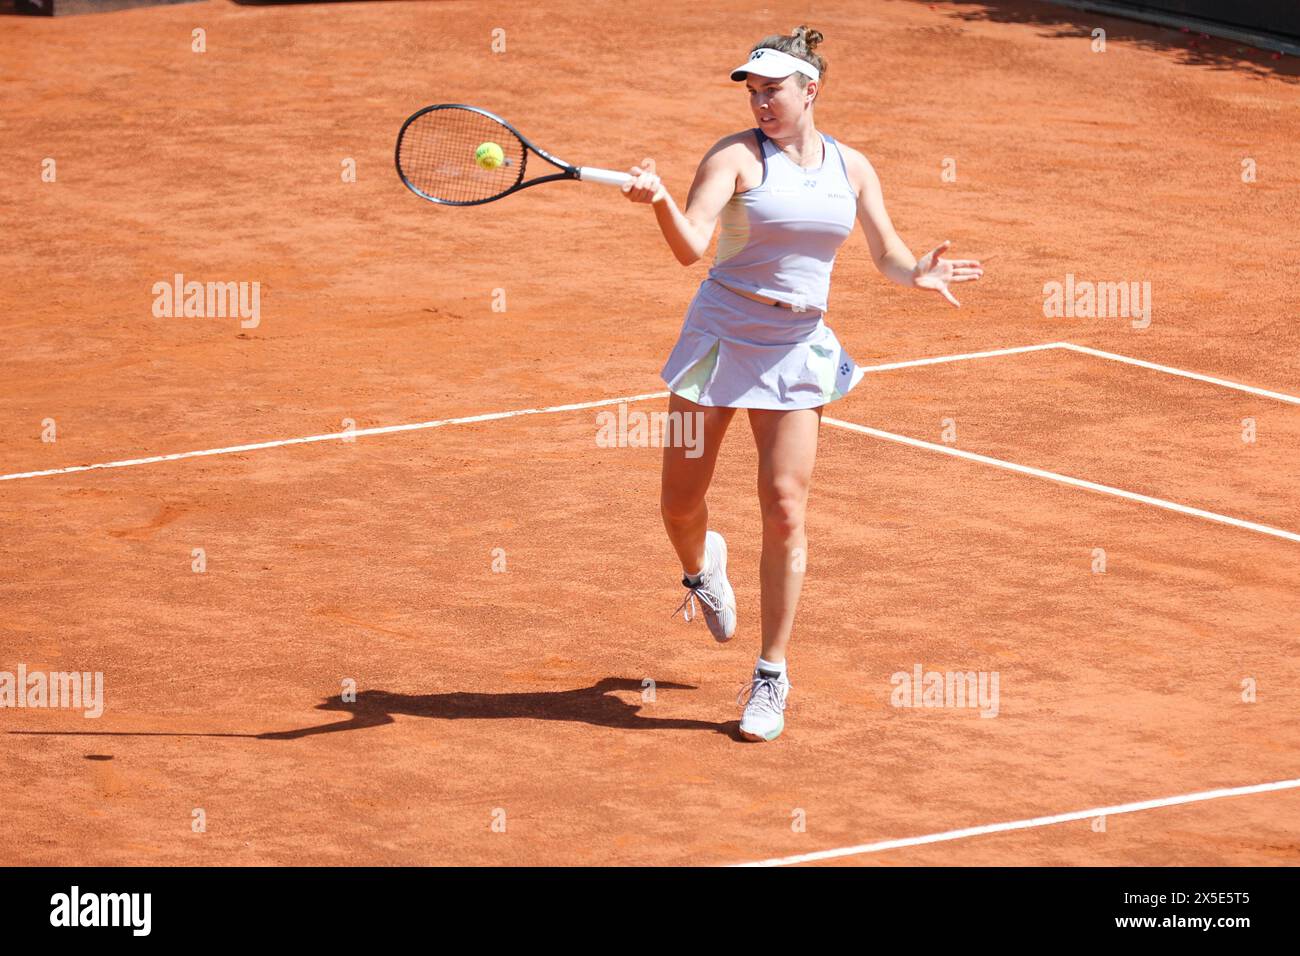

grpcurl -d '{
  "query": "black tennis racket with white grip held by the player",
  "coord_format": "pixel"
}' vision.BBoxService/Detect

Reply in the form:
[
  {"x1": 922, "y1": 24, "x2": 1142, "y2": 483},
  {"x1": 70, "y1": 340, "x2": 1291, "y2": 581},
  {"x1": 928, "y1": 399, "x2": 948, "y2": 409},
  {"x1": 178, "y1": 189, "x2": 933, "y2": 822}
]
[{"x1": 397, "y1": 103, "x2": 632, "y2": 206}]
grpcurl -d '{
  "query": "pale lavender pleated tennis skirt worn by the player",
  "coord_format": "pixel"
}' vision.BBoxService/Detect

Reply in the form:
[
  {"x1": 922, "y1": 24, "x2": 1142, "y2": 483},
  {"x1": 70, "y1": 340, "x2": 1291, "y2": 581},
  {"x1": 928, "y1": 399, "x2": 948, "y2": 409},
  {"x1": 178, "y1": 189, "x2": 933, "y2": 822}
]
[{"x1": 660, "y1": 278, "x2": 863, "y2": 410}]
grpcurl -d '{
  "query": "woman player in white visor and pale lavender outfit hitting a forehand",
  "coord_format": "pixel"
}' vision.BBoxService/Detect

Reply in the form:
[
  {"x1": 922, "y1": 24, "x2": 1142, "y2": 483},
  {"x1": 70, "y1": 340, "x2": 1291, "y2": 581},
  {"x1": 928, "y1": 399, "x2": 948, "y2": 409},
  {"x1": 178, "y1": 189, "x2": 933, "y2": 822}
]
[{"x1": 623, "y1": 26, "x2": 984, "y2": 740}]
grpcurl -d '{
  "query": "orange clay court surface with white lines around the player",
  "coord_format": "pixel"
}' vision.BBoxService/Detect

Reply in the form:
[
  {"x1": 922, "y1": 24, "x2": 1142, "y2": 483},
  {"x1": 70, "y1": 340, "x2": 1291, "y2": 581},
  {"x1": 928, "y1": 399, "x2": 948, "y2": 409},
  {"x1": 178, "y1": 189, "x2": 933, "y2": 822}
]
[{"x1": 0, "y1": 0, "x2": 1300, "y2": 865}]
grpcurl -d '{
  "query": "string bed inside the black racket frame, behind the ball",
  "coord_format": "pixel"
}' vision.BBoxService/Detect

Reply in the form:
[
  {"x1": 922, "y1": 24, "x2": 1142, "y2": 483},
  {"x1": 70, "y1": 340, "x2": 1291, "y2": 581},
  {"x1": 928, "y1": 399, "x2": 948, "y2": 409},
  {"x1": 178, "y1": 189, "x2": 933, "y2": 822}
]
[{"x1": 398, "y1": 107, "x2": 525, "y2": 203}]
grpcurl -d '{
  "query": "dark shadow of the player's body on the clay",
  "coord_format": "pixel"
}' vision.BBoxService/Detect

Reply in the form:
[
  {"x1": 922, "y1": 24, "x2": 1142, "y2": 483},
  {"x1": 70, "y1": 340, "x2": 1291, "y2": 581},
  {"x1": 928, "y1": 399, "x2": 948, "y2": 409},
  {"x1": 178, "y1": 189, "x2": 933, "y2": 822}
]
[{"x1": 255, "y1": 678, "x2": 736, "y2": 740}]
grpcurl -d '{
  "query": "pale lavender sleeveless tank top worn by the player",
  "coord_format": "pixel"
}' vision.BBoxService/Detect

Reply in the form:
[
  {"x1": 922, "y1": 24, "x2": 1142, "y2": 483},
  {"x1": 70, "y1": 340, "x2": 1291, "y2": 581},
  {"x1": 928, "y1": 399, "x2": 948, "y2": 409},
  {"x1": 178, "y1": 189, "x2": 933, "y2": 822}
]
[{"x1": 709, "y1": 129, "x2": 858, "y2": 312}]
